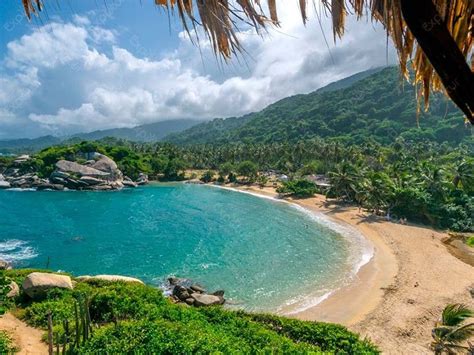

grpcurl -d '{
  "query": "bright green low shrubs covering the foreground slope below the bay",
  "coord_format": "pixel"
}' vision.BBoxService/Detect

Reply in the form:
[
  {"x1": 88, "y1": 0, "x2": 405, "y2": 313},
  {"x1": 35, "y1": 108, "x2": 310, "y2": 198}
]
[{"x1": 1, "y1": 270, "x2": 378, "y2": 354}]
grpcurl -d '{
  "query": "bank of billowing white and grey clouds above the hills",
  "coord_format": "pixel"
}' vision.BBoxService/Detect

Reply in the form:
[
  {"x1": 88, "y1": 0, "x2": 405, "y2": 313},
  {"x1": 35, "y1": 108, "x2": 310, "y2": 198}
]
[{"x1": 0, "y1": 7, "x2": 395, "y2": 138}]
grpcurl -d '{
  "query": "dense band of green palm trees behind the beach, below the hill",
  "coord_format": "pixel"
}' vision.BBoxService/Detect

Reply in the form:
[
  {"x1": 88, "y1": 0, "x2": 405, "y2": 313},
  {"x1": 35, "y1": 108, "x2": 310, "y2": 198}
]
[{"x1": 0, "y1": 134, "x2": 474, "y2": 231}]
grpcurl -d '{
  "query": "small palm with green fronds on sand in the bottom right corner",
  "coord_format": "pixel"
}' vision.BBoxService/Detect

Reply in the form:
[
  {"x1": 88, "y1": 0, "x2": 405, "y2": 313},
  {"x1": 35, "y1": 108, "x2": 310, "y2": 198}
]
[{"x1": 431, "y1": 304, "x2": 474, "y2": 354}]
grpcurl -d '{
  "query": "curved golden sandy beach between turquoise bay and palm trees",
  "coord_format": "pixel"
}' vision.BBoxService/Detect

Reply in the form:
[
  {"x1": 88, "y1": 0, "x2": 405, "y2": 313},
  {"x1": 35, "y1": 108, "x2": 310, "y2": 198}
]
[{"x1": 231, "y1": 186, "x2": 474, "y2": 354}]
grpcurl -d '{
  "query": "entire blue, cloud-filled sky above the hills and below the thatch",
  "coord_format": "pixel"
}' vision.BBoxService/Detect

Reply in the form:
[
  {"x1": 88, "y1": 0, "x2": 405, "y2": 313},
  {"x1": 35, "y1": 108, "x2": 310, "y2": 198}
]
[{"x1": 0, "y1": 0, "x2": 396, "y2": 139}]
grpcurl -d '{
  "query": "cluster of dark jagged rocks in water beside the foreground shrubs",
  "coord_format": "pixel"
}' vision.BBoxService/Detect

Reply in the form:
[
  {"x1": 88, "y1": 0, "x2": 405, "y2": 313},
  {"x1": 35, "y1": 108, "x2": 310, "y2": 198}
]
[{"x1": 167, "y1": 277, "x2": 225, "y2": 307}]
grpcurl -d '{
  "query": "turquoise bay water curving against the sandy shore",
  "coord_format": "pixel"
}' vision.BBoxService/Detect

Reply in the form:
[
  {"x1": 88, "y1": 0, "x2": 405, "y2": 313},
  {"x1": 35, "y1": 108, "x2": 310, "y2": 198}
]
[{"x1": 0, "y1": 184, "x2": 351, "y2": 311}]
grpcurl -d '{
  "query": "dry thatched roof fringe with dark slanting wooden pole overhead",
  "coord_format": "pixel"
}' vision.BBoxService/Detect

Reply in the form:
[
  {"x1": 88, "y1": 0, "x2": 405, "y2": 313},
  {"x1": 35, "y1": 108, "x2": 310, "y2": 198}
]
[{"x1": 22, "y1": 0, "x2": 474, "y2": 124}]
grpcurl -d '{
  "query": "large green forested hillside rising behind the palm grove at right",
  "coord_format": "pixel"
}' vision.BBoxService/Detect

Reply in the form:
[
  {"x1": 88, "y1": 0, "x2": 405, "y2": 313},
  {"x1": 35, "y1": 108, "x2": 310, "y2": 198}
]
[{"x1": 165, "y1": 67, "x2": 472, "y2": 144}]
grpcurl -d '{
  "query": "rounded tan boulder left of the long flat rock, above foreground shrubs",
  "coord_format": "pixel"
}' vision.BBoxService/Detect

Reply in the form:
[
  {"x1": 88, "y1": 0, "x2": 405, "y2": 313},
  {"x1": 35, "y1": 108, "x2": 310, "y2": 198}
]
[{"x1": 22, "y1": 272, "x2": 73, "y2": 298}]
